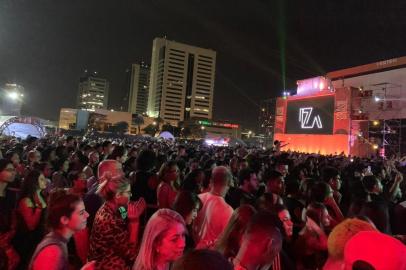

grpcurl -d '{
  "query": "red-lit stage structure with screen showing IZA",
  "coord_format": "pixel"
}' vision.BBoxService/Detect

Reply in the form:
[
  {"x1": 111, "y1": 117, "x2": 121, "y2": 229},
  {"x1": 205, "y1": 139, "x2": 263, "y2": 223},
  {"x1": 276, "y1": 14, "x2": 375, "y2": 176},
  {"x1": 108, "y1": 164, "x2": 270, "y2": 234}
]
[{"x1": 274, "y1": 77, "x2": 375, "y2": 157}]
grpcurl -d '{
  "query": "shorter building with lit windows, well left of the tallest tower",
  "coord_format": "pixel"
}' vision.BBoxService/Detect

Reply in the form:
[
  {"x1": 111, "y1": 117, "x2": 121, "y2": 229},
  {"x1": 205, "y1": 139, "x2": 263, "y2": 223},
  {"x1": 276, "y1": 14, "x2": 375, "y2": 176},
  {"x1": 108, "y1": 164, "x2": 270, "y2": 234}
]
[{"x1": 77, "y1": 75, "x2": 109, "y2": 110}]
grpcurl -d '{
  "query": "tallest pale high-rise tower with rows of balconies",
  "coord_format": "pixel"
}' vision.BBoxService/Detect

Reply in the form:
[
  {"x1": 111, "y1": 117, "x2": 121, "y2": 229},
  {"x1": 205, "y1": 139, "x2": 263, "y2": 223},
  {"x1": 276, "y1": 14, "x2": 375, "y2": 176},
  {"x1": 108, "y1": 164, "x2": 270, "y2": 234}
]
[{"x1": 148, "y1": 38, "x2": 216, "y2": 123}]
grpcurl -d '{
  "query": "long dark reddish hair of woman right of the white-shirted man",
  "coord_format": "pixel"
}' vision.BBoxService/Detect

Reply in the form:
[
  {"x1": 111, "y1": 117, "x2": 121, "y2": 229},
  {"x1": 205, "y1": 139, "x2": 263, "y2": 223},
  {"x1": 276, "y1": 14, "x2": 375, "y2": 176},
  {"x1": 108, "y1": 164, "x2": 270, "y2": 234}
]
[{"x1": 216, "y1": 204, "x2": 257, "y2": 258}]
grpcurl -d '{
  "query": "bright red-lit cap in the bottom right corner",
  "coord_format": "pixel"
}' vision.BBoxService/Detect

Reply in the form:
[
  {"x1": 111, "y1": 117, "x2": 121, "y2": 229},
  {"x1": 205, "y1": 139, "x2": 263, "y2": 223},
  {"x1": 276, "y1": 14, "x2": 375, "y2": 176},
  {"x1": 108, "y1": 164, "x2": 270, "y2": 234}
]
[{"x1": 344, "y1": 231, "x2": 406, "y2": 270}]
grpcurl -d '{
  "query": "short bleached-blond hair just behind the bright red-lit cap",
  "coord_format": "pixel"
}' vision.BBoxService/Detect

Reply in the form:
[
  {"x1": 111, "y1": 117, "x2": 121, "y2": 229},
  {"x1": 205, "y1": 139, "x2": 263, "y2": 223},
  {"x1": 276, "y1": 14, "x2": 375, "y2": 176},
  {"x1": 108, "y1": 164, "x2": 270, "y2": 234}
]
[{"x1": 327, "y1": 218, "x2": 376, "y2": 260}]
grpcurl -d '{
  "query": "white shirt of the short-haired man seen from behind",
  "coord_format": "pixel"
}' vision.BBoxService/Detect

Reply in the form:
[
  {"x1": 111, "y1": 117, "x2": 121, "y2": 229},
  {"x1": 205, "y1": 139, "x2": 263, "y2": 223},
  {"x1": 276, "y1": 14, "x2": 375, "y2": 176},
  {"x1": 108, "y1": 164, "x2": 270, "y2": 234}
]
[{"x1": 193, "y1": 192, "x2": 233, "y2": 249}]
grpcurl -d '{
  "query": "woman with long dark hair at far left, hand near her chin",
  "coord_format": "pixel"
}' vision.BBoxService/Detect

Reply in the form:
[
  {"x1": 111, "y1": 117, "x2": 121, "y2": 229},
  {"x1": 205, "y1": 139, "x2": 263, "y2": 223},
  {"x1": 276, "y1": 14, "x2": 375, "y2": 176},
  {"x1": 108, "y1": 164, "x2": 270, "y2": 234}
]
[{"x1": 14, "y1": 170, "x2": 47, "y2": 267}]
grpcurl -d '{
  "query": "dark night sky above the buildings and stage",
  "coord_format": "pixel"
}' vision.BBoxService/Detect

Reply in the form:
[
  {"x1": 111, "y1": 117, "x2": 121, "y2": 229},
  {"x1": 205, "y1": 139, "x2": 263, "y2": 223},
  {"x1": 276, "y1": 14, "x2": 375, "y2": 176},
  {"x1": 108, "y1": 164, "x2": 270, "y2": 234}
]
[{"x1": 0, "y1": 0, "x2": 406, "y2": 128}]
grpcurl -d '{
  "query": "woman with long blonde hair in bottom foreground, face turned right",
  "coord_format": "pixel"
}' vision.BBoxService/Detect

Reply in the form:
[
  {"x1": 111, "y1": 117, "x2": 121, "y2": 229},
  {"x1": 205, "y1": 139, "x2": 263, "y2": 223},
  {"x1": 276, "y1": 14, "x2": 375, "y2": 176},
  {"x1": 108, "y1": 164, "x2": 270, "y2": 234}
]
[{"x1": 133, "y1": 209, "x2": 186, "y2": 270}]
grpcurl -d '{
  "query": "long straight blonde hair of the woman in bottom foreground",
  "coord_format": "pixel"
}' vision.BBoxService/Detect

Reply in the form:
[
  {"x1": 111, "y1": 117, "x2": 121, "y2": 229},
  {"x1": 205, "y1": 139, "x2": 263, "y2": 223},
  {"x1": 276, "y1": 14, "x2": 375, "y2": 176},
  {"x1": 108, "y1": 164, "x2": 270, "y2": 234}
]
[{"x1": 133, "y1": 208, "x2": 186, "y2": 270}]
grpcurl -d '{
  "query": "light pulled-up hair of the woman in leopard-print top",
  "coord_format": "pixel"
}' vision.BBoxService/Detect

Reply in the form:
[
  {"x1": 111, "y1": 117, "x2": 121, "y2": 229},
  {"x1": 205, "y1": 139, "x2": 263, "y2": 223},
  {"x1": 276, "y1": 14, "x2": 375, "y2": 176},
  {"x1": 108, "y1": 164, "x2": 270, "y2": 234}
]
[{"x1": 96, "y1": 171, "x2": 130, "y2": 201}]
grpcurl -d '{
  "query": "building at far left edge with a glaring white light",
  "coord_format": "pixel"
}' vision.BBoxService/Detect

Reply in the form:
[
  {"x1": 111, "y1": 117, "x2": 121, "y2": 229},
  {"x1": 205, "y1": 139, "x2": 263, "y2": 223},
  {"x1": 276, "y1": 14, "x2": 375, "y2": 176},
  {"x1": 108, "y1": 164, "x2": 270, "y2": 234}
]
[{"x1": 0, "y1": 83, "x2": 24, "y2": 116}]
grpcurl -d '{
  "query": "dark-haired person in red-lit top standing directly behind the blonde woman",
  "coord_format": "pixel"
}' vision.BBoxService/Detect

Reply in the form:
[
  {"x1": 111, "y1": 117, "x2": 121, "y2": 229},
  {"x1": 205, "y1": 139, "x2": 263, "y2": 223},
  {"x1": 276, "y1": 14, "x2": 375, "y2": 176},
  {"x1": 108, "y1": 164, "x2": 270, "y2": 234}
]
[{"x1": 157, "y1": 161, "x2": 179, "y2": 208}]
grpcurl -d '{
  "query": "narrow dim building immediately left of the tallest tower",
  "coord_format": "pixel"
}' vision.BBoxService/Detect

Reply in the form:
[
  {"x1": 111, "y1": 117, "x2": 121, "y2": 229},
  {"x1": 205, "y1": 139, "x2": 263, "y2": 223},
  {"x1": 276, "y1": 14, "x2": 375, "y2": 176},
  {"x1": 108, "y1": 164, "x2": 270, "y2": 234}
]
[{"x1": 128, "y1": 62, "x2": 150, "y2": 114}]
